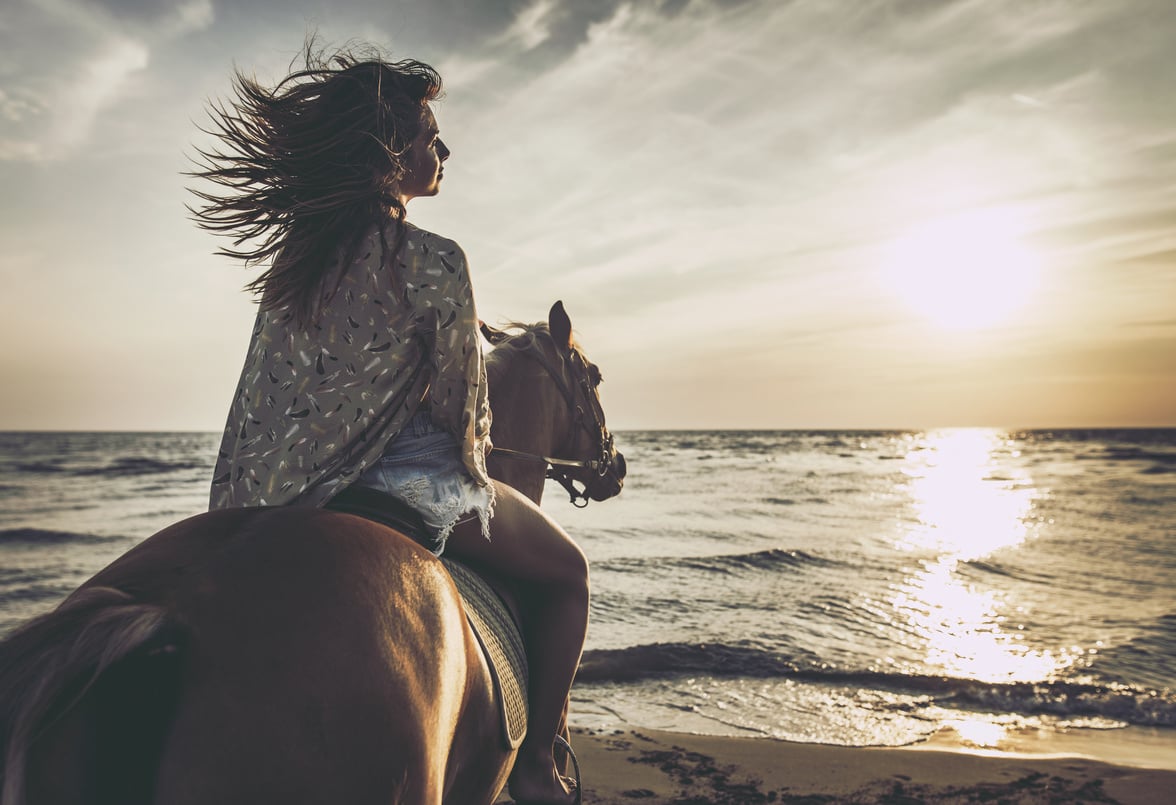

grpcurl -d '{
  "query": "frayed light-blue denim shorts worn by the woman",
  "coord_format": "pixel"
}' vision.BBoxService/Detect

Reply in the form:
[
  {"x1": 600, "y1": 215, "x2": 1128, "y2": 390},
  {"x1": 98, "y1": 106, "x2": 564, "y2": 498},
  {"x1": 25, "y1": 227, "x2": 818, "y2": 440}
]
[{"x1": 355, "y1": 410, "x2": 492, "y2": 556}]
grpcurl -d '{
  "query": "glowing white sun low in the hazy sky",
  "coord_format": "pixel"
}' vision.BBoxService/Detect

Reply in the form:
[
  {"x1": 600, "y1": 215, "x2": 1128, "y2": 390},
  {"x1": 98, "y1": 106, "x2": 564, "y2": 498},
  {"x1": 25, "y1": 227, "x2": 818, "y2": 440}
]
[{"x1": 883, "y1": 210, "x2": 1041, "y2": 330}]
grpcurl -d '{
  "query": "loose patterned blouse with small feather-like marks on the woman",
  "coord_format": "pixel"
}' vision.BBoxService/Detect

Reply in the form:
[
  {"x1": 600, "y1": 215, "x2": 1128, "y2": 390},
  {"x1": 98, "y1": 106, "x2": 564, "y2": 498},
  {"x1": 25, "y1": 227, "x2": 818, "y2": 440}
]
[{"x1": 209, "y1": 220, "x2": 490, "y2": 509}]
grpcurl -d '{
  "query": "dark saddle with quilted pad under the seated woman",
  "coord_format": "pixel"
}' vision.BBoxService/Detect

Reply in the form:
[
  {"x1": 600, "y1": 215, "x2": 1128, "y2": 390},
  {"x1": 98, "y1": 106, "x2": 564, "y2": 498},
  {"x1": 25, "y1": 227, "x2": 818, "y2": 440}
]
[{"x1": 326, "y1": 487, "x2": 528, "y2": 749}]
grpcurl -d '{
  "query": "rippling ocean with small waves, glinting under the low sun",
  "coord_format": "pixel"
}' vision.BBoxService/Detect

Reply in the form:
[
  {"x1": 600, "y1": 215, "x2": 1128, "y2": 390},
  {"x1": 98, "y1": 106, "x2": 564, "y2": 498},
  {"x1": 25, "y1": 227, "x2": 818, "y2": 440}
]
[{"x1": 0, "y1": 429, "x2": 1176, "y2": 764}]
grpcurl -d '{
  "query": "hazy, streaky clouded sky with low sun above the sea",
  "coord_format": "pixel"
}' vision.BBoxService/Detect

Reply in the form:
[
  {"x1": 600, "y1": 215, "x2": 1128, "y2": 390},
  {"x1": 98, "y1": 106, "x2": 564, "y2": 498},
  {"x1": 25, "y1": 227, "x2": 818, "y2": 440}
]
[{"x1": 0, "y1": 0, "x2": 1176, "y2": 430}]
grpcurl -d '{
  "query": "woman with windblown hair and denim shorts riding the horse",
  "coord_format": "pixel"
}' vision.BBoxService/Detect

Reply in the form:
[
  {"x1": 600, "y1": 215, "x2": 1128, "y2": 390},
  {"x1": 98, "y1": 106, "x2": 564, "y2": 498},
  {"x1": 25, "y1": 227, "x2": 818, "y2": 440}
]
[{"x1": 193, "y1": 48, "x2": 588, "y2": 803}]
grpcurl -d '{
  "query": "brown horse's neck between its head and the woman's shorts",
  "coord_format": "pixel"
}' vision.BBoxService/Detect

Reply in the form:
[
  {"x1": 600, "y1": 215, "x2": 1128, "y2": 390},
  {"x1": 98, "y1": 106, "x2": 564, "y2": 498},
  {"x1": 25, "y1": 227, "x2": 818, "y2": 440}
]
[{"x1": 488, "y1": 355, "x2": 566, "y2": 503}]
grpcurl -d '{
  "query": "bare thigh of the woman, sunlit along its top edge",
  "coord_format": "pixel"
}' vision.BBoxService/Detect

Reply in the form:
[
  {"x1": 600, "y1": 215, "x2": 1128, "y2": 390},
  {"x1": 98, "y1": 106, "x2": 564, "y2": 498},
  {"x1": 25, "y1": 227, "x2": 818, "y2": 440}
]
[{"x1": 446, "y1": 482, "x2": 588, "y2": 584}]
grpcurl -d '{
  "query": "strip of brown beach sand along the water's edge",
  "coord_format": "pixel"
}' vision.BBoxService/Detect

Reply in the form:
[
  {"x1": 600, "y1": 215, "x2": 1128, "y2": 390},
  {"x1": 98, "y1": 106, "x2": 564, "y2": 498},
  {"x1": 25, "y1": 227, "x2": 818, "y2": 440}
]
[{"x1": 499, "y1": 730, "x2": 1176, "y2": 805}]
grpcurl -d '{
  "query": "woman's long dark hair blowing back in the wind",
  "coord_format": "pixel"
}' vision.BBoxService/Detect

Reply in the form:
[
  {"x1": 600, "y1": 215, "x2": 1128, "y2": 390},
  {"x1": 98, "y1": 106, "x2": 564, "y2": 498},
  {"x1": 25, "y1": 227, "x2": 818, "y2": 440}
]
[{"x1": 188, "y1": 42, "x2": 441, "y2": 322}]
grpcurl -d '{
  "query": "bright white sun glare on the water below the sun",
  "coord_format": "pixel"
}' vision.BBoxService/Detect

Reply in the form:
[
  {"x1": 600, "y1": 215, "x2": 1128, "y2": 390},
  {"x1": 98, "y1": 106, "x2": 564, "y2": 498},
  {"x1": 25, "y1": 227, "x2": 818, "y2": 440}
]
[{"x1": 889, "y1": 429, "x2": 1075, "y2": 682}]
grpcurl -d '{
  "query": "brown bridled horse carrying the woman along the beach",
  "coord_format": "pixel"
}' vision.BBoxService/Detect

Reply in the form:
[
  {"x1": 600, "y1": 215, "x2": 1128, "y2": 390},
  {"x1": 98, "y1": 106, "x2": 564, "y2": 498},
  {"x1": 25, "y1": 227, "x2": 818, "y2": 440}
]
[{"x1": 0, "y1": 303, "x2": 624, "y2": 805}]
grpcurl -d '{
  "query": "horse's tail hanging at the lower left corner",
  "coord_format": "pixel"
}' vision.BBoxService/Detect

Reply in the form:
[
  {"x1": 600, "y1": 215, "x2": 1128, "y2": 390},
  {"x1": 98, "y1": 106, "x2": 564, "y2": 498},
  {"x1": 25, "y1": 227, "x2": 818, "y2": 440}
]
[{"x1": 0, "y1": 586, "x2": 176, "y2": 805}]
